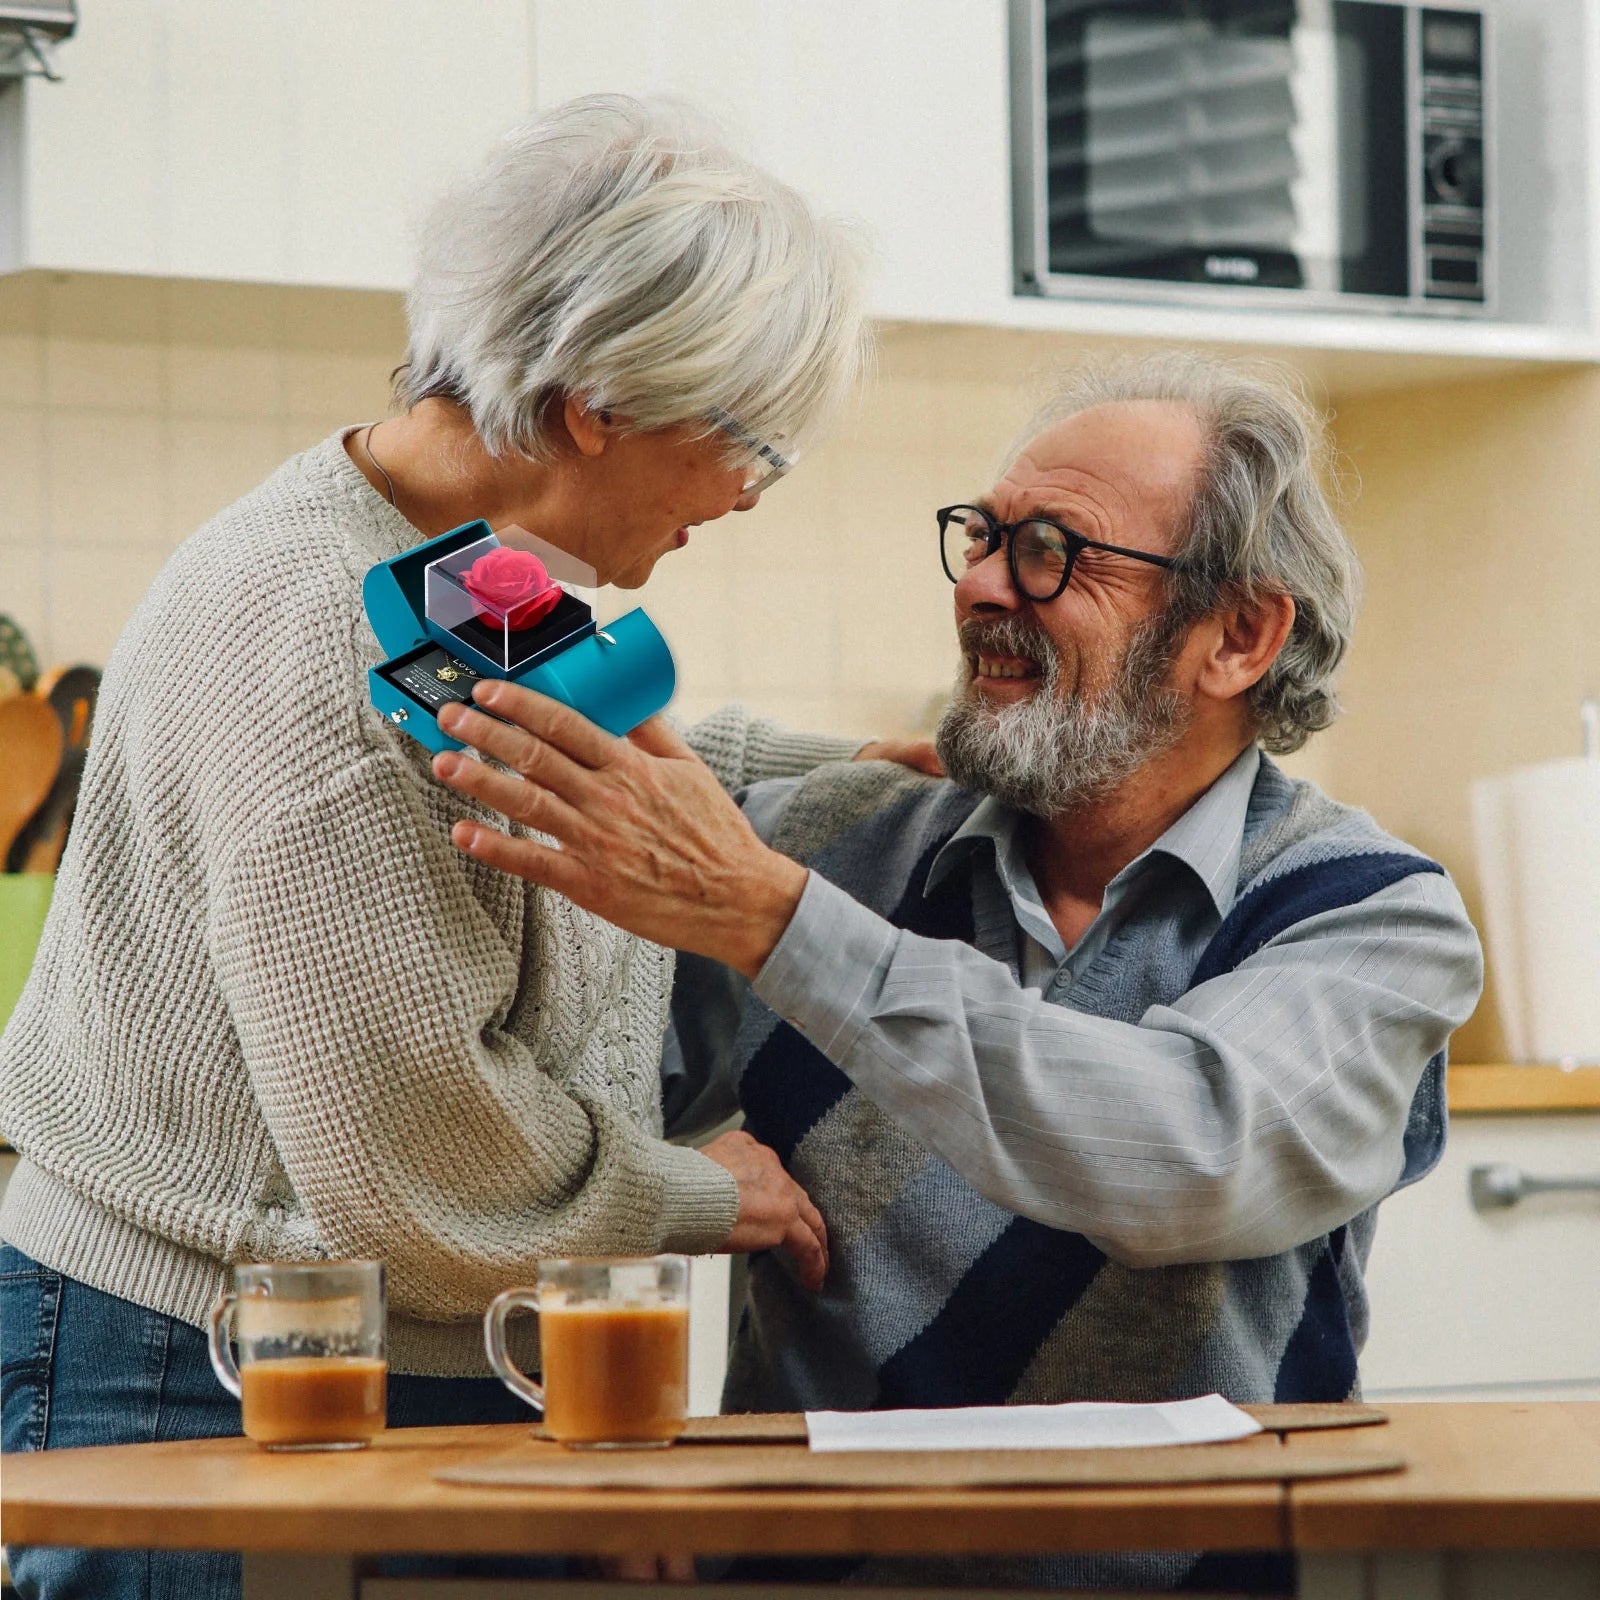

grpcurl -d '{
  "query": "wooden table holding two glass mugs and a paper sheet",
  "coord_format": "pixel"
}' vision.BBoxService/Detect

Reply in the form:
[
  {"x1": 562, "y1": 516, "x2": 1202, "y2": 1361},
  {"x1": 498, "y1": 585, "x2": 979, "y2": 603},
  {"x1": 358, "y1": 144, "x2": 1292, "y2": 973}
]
[{"x1": 3, "y1": 1403, "x2": 1600, "y2": 1600}]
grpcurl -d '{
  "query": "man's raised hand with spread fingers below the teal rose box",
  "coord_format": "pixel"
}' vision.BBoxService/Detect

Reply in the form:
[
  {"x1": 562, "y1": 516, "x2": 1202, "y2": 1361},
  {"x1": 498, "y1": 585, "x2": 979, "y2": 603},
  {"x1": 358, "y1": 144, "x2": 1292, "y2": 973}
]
[{"x1": 434, "y1": 680, "x2": 806, "y2": 978}]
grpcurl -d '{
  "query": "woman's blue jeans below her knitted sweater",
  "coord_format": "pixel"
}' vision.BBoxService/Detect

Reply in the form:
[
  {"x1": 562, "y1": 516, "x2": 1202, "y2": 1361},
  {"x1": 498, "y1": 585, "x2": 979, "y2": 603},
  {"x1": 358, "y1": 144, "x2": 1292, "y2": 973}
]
[{"x1": 0, "y1": 1245, "x2": 568, "y2": 1600}]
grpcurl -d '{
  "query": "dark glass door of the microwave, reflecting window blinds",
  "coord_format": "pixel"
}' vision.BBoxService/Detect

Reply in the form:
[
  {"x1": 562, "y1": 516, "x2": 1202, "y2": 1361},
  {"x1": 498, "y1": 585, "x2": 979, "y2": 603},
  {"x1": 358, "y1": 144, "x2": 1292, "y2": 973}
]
[{"x1": 1038, "y1": 0, "x2": 1408, "y2": 296}]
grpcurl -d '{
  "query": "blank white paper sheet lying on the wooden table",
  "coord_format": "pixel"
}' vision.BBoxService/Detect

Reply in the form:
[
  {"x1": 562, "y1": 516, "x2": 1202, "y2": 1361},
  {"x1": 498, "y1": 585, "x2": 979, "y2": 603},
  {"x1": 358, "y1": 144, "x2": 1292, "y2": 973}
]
[{"x1": 805, "y1": 1395, "x2": 1261, "y2": 1451}]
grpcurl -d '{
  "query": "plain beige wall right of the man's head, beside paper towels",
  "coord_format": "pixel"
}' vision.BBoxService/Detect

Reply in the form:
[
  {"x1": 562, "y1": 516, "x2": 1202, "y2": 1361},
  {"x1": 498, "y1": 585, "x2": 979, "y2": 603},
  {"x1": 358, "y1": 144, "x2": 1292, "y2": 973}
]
[{"x1": 1326, "y1": 370, "x2": 1600, "y2": 1061}]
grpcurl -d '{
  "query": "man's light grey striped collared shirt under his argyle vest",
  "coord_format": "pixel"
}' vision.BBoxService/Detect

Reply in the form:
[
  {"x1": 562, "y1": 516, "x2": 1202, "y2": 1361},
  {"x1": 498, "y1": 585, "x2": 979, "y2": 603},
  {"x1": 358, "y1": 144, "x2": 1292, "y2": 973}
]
[{"x1": 664, "y1": 750, "x2": 1483, "y2": 1266}]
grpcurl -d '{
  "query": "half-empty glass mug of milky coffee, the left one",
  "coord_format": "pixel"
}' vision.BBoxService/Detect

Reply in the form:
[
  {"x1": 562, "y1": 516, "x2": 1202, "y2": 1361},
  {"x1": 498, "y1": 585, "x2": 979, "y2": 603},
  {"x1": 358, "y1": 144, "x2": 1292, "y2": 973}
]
[{"x1": 211, "y1": 1261, "x2": 389, "y2": 1450}]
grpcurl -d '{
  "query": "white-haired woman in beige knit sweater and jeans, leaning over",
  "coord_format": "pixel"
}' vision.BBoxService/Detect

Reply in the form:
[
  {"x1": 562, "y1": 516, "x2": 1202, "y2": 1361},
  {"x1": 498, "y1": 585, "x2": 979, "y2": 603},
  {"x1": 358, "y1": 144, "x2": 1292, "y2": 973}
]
[{"x1": 0, "y1": 98, "x2": 862, "y2": 1595}]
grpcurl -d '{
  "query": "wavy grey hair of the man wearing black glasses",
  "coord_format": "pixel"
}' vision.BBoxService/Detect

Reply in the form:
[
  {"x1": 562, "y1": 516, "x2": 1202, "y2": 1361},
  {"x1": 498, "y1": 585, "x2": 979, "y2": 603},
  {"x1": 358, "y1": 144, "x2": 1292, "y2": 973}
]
[{"x1": 1010, "y1": 350, "x2": 1362, "y2": 754}]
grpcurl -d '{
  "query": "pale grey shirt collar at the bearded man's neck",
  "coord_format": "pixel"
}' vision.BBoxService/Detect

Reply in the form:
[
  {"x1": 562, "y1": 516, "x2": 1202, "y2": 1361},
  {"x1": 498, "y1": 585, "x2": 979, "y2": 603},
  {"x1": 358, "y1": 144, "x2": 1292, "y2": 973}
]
[{"x1": 923, "y1": 744, "x2": 1261, "y2": 917}]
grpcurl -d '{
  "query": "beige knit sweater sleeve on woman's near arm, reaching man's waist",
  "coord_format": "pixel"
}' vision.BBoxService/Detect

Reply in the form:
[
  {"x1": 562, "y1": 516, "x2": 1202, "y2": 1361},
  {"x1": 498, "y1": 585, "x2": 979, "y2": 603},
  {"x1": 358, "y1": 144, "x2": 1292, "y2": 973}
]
[{"x1": 210, "y1": 750, "x2": 738, "y2": 1318}]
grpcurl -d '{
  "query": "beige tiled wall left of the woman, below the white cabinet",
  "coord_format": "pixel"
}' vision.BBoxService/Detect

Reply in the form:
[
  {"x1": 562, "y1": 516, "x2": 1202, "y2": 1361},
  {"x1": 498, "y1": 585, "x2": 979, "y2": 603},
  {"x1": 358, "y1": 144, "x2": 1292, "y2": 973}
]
[{"x1": 0, "y1": 274, "x2": 403, "y2": 662}]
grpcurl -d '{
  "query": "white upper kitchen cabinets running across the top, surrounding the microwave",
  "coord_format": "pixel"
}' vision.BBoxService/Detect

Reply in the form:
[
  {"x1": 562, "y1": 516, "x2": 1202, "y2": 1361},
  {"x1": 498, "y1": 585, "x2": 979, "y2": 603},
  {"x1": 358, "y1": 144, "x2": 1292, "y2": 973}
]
[{"x1": 0, "y1": 0, "x2": 1600, "y2": 366}]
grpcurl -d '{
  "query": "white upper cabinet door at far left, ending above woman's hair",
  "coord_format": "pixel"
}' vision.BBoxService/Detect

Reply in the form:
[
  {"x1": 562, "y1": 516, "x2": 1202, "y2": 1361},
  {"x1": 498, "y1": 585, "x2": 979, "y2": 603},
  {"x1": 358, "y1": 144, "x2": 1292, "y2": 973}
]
[{"x1": 0, "y1": 0, "x2": 533, "y2": 288}]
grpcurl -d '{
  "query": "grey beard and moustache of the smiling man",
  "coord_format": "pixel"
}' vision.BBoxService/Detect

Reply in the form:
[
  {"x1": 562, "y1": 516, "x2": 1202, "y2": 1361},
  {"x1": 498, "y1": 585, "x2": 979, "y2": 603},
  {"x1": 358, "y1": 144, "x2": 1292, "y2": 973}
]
[{"x1": 934, "y1": 614, "x2": 1192, "y2": 819}]
